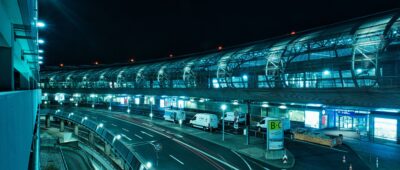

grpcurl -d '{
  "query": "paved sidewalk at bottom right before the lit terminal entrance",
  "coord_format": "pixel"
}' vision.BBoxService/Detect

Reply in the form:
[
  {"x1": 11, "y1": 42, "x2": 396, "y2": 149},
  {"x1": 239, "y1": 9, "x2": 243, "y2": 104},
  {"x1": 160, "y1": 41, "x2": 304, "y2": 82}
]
[{"x1": 323, "y1": 130, "x2": 400, "y2": 169}]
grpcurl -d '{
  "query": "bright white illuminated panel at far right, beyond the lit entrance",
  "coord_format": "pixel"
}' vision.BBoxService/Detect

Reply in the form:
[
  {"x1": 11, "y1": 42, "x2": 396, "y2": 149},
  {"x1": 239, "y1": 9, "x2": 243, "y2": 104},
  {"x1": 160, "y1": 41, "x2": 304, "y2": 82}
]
[{"x1": 370, "y1": 111, "x2": 400, "y2": 144}]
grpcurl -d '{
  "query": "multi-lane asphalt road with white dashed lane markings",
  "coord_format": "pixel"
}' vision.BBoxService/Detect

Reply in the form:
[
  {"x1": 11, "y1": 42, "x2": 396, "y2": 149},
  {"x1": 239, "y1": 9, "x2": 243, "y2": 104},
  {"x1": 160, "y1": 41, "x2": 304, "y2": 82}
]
[{"x1": 57, "y1": 108, "x2": 274, "y2": 170}]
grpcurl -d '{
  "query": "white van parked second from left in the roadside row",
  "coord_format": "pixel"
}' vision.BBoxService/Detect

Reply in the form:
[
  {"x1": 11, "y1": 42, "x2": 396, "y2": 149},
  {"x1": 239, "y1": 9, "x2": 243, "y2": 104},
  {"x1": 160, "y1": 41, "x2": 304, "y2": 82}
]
[{"x1": 189, "y1": 113, "x2": 218, "y2": 129}]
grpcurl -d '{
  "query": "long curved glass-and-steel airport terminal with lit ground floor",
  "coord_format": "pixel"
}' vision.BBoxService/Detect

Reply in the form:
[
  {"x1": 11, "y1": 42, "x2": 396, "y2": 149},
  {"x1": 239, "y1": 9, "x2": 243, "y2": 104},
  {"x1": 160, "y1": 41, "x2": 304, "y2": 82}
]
[{"x1": 40, "y1": 10, "x2": 400, "y2": 143}]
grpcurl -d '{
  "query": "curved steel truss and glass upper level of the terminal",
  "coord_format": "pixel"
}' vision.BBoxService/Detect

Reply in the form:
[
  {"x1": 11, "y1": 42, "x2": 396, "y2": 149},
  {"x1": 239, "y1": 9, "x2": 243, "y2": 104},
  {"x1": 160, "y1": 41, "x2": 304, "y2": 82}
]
[{"x1": 41, "y1": 10, "x2": 400, "y2": 88}]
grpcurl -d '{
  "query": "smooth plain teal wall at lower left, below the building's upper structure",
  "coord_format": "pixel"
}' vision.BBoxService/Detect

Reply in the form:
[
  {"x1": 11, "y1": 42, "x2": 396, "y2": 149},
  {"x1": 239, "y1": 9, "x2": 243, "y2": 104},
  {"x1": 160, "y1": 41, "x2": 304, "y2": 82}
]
[{"x1": 0, "y1": 90, "x2": 40, "y2": 170}]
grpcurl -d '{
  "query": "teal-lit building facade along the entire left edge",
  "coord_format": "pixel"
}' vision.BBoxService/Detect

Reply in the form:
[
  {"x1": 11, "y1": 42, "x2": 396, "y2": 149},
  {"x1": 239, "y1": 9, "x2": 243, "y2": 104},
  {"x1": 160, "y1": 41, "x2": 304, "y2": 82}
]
[{"x1": 0, "y1": 0, "x2": 41, "y2": 170}]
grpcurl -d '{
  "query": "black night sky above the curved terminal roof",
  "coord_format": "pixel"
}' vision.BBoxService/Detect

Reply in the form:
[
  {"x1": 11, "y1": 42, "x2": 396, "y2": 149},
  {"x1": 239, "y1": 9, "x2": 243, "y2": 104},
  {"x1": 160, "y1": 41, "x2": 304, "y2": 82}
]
[{"x1": 39, "y1": 0, "x2": 400, "y2": 66}]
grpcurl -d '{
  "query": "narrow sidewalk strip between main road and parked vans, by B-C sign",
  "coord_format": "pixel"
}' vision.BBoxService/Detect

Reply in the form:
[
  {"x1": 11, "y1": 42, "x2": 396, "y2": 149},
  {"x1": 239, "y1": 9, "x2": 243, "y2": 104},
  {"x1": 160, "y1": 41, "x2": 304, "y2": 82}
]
[{"x1": 114, "y1": 113, "x2": 295, "y2": 169}]
